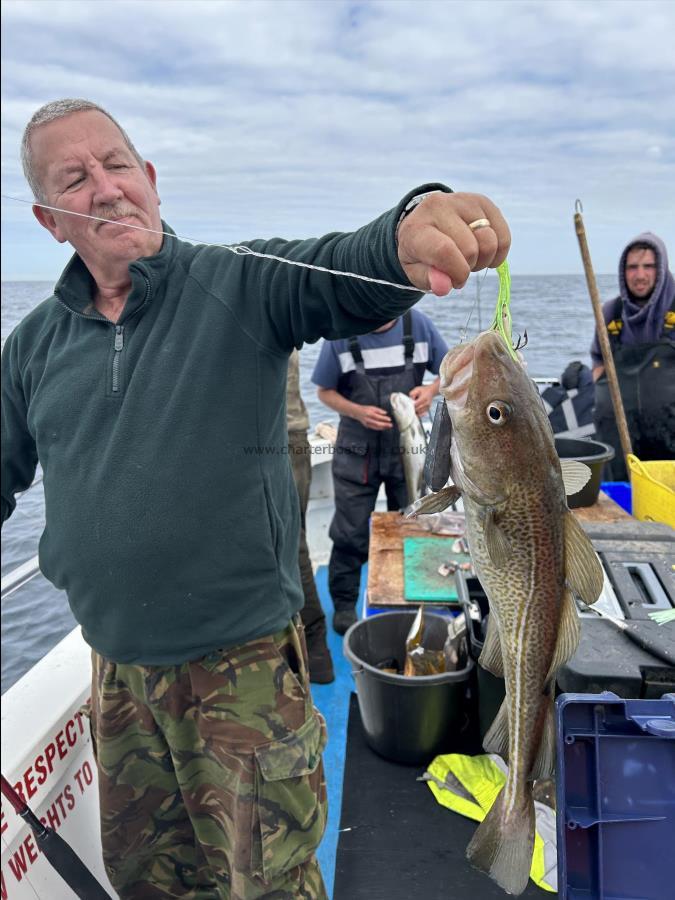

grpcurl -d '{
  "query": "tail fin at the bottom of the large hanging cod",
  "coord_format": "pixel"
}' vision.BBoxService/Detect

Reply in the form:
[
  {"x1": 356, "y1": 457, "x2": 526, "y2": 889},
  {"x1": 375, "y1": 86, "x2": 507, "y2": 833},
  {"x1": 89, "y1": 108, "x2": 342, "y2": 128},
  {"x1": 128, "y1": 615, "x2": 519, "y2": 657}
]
[{"x1": 466, "y1": 782, "x2": 535, "y2": 895}]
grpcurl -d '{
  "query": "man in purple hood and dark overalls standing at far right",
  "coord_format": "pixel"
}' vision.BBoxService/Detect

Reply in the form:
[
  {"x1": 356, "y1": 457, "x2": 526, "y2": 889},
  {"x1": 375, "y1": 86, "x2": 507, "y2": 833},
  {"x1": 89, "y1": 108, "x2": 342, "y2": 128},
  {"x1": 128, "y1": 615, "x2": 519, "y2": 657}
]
[{"x1": 591, "y1": 231, "x2": 675, "y2": 481}]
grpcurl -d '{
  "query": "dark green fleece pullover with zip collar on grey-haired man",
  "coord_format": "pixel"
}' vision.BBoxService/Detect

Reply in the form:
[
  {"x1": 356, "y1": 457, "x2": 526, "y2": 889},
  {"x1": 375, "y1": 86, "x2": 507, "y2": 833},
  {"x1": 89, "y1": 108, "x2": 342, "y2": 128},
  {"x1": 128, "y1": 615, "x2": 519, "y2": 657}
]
[{"x1": 2, "y1": 185, "x2": 447, "y2": 665}]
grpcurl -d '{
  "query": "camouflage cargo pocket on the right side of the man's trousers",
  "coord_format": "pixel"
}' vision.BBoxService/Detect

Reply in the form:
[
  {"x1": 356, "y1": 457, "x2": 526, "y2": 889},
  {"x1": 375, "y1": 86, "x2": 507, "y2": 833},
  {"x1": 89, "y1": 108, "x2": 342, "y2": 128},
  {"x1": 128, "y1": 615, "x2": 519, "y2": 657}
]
[{"x1": 253, "y1": 710, "x2": 328, "y2": 881}]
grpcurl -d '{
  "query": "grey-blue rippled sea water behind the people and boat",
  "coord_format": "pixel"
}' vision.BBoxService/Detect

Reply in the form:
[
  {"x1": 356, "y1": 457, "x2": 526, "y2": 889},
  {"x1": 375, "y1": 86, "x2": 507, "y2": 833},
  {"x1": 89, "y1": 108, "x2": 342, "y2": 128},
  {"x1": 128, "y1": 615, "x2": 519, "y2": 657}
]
[{"x1": 2, "y1": 274, "x2": 617, "y2": 693}]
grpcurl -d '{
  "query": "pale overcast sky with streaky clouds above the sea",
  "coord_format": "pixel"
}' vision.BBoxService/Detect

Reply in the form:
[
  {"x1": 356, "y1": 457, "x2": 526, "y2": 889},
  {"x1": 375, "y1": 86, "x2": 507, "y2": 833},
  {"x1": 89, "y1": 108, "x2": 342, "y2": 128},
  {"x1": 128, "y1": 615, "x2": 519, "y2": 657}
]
[{"x1": 2, "y1": 0, "x2": 675, "y2": 280}]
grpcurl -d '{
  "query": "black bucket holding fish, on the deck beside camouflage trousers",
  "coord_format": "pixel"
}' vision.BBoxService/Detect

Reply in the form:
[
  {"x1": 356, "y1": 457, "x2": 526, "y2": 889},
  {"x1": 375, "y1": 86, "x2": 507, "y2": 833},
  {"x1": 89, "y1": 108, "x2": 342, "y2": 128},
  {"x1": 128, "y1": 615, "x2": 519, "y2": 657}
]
[{"x1": 344, "y1": 610, "x2": 473, "y2": 765}]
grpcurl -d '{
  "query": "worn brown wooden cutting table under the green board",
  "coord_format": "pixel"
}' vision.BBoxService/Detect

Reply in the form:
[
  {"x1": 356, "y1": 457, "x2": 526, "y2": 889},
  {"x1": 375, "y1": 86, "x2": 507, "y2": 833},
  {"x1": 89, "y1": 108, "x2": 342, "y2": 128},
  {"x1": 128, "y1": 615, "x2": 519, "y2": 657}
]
[{"x1": 366, "y1": 491, "x2": 632, "y2": 608}]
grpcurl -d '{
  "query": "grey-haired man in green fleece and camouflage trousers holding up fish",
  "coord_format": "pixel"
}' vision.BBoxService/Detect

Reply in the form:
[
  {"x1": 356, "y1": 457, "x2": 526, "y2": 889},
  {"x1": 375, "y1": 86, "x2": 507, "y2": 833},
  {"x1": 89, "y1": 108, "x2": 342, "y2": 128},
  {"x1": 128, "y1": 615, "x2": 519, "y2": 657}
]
[{"x1": 2, "y1": 100, "x2": 510, "y2": 900}]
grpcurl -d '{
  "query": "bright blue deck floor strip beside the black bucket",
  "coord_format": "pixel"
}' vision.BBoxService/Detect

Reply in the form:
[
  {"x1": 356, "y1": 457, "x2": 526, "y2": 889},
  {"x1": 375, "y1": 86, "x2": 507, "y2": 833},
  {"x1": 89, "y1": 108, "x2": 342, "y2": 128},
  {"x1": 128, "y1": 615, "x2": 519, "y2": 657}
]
[{"x1": 312, "y1": 566, "x2": 368, "y2": 897}]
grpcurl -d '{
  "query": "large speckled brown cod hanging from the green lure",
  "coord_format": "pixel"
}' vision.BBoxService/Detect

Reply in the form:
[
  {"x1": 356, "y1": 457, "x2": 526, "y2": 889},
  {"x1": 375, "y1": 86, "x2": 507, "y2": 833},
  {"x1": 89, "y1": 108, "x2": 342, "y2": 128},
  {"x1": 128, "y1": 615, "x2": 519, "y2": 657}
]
[{"x1": 412, "y1": 331, "x2": 603, "y2": 894}]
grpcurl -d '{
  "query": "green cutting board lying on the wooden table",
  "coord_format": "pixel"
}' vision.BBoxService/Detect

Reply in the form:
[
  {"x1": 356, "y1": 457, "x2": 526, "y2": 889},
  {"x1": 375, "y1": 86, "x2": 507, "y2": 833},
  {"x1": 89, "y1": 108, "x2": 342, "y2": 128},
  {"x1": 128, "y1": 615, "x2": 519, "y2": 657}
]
[{"x1": 403, "y1": 537, "x2": 471, "y2": 603}]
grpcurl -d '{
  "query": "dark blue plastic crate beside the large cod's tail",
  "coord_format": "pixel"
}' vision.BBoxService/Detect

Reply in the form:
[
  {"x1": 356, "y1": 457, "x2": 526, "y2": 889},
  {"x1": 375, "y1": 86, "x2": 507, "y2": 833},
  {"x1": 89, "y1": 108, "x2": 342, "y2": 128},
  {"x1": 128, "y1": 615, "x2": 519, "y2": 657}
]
[{"x1": 556, "y1": 692, "x2": 675, "y2": 900}]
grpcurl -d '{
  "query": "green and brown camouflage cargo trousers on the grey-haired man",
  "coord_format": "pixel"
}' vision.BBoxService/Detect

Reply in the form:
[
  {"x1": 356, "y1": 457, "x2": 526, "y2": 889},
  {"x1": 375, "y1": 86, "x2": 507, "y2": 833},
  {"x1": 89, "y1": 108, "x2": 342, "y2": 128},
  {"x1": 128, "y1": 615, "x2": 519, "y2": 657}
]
[{"x1": 91, "y1": 616, "x2": 327, "y2": 900}]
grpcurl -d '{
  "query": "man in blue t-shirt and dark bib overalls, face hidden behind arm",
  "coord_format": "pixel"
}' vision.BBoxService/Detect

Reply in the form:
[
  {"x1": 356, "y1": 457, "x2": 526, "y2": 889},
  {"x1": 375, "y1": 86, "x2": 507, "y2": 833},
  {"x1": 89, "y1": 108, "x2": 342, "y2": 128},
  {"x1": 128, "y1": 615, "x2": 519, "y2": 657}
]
[{"x1": 312, "y1": 310, "x2": 448, "y2": 634}]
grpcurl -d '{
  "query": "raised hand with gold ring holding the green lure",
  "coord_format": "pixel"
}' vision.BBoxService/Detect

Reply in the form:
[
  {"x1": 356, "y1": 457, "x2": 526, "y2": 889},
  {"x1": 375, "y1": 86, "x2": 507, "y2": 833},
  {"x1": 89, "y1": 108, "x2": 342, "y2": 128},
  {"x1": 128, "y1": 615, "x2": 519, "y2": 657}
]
[{"x1": 398, "y1": 193, "x2": 511, "y2": 297}]
